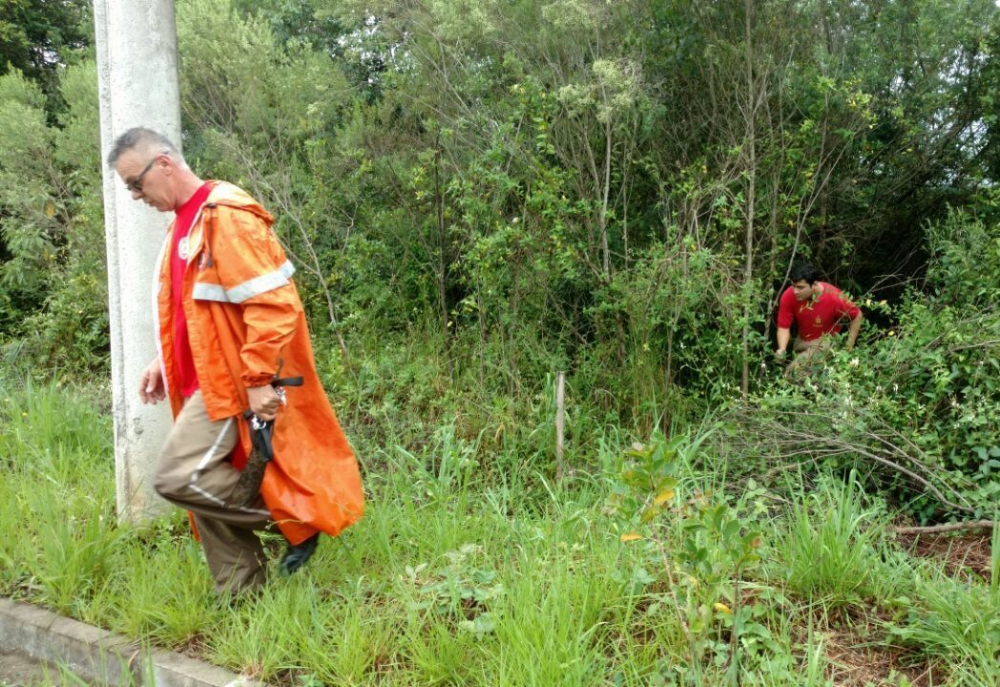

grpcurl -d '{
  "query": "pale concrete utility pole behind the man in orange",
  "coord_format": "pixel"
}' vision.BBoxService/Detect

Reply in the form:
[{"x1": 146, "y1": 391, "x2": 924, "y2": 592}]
[{"x1": 94, "y1": 0, "x2": 181, "y2": 523}]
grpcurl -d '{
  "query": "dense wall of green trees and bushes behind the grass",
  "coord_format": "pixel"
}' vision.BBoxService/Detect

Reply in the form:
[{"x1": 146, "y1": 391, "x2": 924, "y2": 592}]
[{"x1": 0, "y1": 0, "x2": 1000, "y2": 517}]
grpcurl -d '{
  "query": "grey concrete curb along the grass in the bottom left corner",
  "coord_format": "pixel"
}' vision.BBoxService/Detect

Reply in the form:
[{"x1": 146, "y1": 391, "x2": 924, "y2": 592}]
[{"x1": 0, "y1": 598, "x2": 266, "y2": 687}]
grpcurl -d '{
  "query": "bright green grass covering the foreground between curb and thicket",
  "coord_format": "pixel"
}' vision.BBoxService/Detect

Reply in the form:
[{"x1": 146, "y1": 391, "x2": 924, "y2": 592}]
[{"x1": 0, "y1": 384, "x2": 1000, "y2": 687}]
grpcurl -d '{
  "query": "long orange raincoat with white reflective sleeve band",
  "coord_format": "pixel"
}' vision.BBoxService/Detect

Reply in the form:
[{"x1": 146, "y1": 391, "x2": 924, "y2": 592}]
[{"x1": 156, "y1": 182, "x2": 364, "y2": 545}]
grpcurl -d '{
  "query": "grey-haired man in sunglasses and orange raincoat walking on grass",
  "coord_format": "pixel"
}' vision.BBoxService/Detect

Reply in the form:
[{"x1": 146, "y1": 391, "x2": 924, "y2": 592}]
[{"x1": 108, "y1": 128, "x2": 364, "y2": 593}]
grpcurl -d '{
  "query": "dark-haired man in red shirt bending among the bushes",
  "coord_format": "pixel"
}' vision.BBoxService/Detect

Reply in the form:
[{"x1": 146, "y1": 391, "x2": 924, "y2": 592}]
[{"x1": 775, "y1": 264, "x2": 864, "y2": 371}]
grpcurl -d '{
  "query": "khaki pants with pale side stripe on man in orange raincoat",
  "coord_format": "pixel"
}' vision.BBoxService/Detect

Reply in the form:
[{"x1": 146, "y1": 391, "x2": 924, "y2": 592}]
[{"x1": 154, "y1": 391, "x2": 271, "y2": 593}]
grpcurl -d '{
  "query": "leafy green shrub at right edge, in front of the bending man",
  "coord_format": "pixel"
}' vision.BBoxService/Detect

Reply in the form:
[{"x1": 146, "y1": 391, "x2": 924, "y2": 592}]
[{"x1": 744, "y1": 212, "x2": 1000, "y2": 520}]
